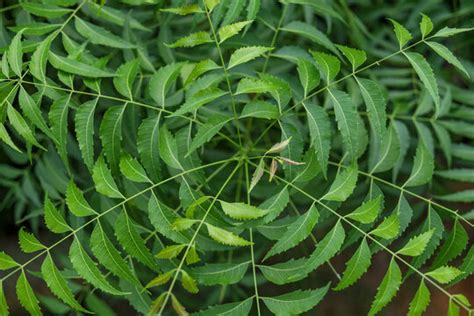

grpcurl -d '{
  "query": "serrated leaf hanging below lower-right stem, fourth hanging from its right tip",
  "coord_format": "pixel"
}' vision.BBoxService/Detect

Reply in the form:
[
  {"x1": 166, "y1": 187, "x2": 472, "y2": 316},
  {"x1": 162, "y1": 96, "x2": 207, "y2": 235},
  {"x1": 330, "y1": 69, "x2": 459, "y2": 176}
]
[{"x1": 334, "y1": 238, "x2": 372, "y2": 291}]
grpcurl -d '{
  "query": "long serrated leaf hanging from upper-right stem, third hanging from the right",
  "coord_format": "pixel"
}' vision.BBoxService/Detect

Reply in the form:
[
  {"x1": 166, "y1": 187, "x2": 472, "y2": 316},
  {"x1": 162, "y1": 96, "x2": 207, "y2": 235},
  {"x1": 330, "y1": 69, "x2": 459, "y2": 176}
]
[{"x1": 328, "y1": 89, "x2": 361, "y2": 161}]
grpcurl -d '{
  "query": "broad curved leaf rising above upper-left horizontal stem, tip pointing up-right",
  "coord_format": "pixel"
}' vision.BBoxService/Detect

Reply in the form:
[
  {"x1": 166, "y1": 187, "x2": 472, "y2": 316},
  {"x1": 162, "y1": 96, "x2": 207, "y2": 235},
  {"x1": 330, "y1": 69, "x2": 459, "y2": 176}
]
[{"x1": 148, "y1": 63, "x2": 184, "y2": 107}]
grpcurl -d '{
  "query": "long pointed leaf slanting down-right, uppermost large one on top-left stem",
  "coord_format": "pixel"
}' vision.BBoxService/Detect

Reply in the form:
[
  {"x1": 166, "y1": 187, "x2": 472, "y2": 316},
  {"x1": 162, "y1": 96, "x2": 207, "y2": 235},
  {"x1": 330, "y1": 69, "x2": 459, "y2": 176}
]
[{"x1": 74, "y1": 16, "x2": 135, "y2": 49}]
